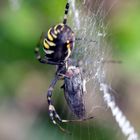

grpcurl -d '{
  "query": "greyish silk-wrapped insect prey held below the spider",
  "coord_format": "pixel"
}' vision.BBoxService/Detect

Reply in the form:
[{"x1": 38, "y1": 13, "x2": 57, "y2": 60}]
[{"x1": 63, "y1": 66, "x2": 86, "y2": 119}]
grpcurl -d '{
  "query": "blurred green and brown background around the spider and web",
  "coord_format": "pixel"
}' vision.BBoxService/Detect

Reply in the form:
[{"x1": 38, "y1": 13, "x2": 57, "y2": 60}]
[{"x1": 0, "y1": 0, "x2": 140, "y2": 140}]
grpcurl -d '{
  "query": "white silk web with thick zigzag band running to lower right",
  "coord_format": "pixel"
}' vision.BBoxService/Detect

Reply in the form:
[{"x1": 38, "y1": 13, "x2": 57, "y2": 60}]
[{"x1": 69, "y1": 0, "x2": 139, "y2": 140}]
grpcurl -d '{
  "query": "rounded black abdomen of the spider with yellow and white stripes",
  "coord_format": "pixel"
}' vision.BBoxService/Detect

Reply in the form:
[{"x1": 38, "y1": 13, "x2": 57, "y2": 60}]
[{"x1": 43, "y1": 23, "x2": 75, "y2": 62}]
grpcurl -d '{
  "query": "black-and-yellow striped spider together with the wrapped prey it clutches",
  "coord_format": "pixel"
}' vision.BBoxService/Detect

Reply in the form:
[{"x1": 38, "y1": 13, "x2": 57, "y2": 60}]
[{"x1": 35, "y1": 2, "x2": 93, "y2": 131}]
